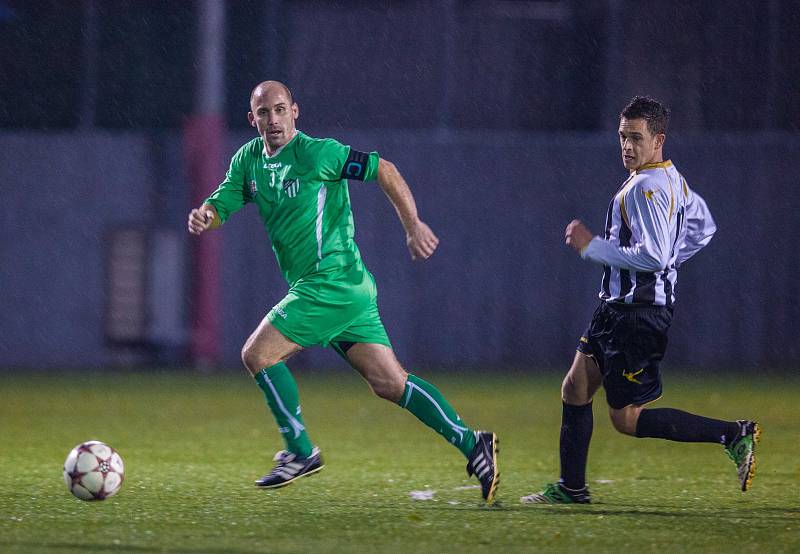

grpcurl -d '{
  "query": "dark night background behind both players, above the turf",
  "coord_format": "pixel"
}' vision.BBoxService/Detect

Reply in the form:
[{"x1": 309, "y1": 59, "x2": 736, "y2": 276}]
[{"x1": 0, "y1": 0, "x2": 800, "y2": 371}]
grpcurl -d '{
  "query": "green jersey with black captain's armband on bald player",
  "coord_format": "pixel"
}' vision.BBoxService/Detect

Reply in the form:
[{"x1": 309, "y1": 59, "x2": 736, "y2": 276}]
[{"x1": 206, "y1": 131, "x2": 379, "y2": 285}]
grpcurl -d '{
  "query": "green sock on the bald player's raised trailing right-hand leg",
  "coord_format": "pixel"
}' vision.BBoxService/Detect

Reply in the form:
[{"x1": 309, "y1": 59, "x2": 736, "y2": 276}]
[{"x1": 398, "y1": 374, "x2": 475, "y2": 458}]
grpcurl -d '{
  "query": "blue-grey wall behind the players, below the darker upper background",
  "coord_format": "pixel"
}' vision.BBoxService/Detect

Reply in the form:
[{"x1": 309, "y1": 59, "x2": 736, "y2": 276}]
[{"x1": 0, "y1": 129, "x2": 800, "y2": 369}]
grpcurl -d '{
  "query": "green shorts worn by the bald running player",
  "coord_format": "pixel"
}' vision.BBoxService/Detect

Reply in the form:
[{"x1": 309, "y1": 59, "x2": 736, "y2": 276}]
[{"x1": 267, "y1": 260, "x2": 391, "y2": 350}]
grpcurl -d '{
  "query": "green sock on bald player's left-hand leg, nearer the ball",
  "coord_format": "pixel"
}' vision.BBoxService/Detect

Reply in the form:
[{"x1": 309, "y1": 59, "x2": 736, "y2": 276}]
[{"x1": 256, "y1": 363, "x2": 314, "y2": 458}]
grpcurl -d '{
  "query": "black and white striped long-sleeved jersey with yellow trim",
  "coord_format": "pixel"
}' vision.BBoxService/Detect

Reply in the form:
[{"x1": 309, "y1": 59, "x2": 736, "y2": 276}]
[{"x1": 581, "y1": 160, "x2": 717, "y2": 306}]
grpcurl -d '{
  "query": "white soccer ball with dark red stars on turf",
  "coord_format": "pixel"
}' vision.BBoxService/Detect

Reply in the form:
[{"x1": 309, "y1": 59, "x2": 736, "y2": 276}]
[{"x1": 64, "y1": 441, "x2": 125, "y2": 500}]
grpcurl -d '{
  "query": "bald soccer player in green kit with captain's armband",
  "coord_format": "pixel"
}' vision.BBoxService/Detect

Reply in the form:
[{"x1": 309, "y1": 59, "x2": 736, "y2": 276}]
[{"x1": 188, "y1": 81, "x2": 498, "y2": 503}]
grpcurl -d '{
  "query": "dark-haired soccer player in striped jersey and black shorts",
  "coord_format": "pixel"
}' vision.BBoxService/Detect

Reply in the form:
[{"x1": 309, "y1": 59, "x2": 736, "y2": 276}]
[{"x1": 520, "y1": 96, "x2": 760, "y2": 504}]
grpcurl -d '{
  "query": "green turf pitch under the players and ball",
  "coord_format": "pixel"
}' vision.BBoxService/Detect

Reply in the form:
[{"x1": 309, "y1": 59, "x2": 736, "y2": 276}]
[{"x1": 0, "y1": 372, "x2": 800, "y2": 552}]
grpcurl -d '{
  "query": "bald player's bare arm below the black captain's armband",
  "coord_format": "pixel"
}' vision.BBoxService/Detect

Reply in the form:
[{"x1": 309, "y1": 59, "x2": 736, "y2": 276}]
[{"x1": 378, "y1": 159, "x2": 439, "y2": 260}]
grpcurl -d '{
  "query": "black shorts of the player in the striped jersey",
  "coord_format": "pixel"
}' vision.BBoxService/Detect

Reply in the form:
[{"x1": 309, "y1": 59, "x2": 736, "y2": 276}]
[{"x1": 578, "y1": 302, "x2": 672, "y2": 409}]
